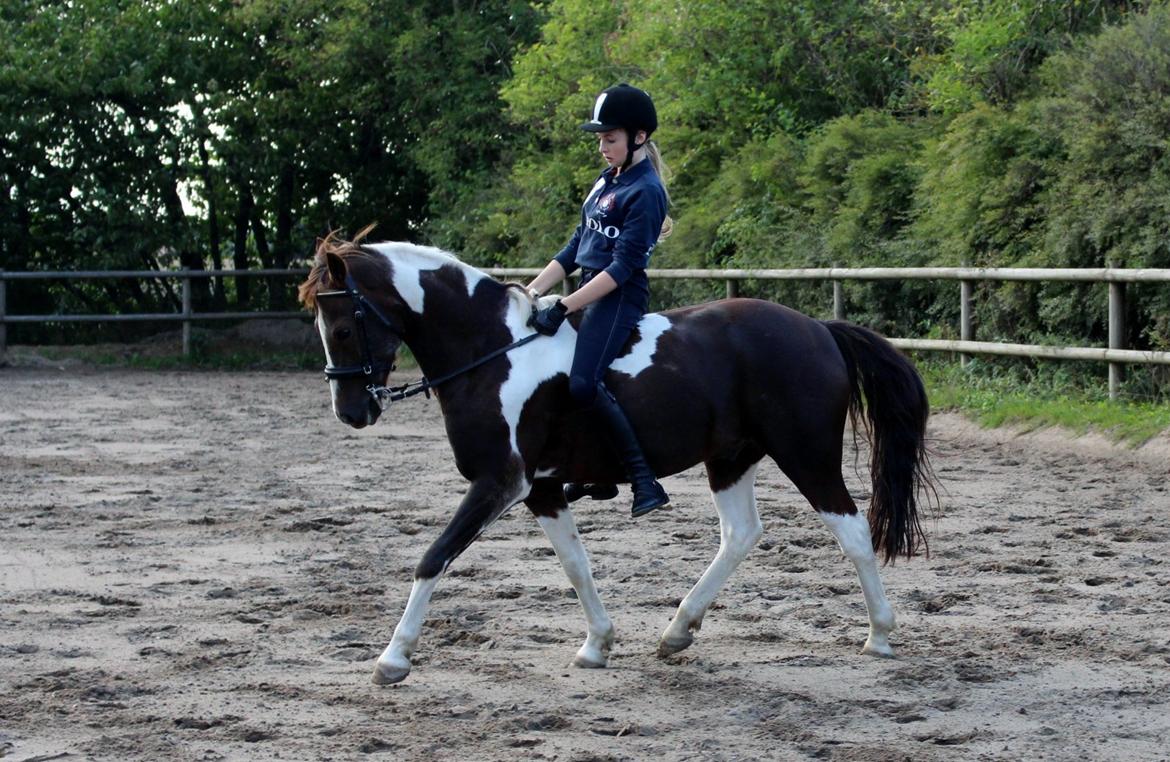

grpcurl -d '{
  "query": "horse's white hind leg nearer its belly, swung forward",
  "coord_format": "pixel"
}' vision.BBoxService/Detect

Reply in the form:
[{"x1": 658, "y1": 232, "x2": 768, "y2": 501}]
[{"x1": 658, "y1": 462, "x2": 764, "y2": 658}]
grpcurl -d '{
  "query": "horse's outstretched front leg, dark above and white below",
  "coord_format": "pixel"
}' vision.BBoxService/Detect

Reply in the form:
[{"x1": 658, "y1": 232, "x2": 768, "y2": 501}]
[{"x1": 373, "y1": 479, "x2": 528, "y2": 685}]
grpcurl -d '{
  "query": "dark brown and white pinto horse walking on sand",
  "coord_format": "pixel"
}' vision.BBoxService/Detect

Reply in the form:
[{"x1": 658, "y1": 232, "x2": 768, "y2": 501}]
[{"x1": 300, "y1": 230, "x2": 932, "y2": 685}]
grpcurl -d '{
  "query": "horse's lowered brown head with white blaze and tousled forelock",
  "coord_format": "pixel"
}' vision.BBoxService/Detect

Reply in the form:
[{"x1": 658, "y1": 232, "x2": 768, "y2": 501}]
[{"x1": 300, "y1": 231, "x2": 404, "y2": 428}]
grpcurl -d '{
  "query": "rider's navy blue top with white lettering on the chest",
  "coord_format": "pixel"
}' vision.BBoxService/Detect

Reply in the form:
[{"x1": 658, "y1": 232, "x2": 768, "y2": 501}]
[{"x1": 553, "y1": 159, "x2": 666, "y2": 288}]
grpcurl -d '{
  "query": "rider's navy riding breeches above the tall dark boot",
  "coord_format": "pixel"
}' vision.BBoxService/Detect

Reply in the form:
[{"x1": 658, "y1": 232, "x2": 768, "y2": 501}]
[{"x1": 569, "y1": 270, "x2": 649, "y2": 406}]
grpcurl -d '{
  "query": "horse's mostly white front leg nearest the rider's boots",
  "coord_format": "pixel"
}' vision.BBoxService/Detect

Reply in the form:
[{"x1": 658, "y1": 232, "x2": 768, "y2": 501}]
[{"x1": 525, "y1": 480, "x2": 613, "y2": 668}]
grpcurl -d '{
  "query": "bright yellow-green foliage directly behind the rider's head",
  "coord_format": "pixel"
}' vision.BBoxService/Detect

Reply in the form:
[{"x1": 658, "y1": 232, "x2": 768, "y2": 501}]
[{"x1": 447, "y1": 0, "x2": 950, "y2": 265}]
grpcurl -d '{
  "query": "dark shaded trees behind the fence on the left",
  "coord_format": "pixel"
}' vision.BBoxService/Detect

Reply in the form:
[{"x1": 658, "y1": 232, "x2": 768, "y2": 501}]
[{"x1": 0, "y1": 0, "x2": 538, "y2": 337}]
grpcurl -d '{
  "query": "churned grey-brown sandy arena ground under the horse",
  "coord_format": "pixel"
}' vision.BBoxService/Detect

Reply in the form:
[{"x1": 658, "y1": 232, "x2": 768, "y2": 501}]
[{"x1": 0, "y1": 368, "x2": 1170, "y2": 761}]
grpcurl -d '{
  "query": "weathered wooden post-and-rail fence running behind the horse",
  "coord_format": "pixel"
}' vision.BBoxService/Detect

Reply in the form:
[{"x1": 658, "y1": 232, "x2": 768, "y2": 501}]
[{"x1": 0, "y1": 267, "x2": 1170, "y2": 398}]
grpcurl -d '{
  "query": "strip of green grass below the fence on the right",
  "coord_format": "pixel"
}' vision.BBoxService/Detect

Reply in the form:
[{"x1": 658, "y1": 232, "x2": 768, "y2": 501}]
[{"x1": 917, "y1": 358, "x2": 1170, "y2": 447}]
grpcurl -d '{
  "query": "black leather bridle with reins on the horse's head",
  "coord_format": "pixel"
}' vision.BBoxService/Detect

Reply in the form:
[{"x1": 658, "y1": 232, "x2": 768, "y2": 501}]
[{"x1": 317, "y1": 273, "x2": 541, "y2": 412}]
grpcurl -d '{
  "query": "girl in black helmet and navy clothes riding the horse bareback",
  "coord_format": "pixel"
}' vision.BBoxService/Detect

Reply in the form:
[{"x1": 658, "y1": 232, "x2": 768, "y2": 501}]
[{"x1": 529, "y1": 83, "x2": 670, "y2": 519}]
